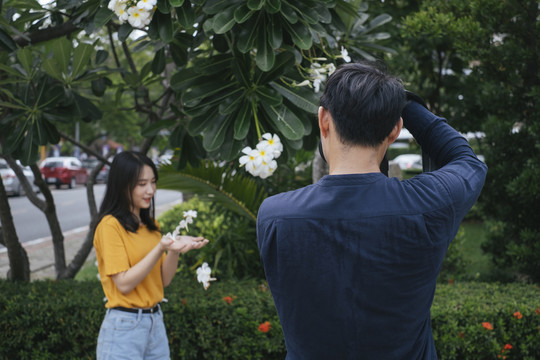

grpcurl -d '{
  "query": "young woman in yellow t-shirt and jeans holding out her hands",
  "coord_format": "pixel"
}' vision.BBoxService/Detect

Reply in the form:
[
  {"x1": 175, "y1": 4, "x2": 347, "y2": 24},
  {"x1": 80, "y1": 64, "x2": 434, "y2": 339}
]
[{"x1": 94, "y1": 151, "x2": 208, "y2": 360}]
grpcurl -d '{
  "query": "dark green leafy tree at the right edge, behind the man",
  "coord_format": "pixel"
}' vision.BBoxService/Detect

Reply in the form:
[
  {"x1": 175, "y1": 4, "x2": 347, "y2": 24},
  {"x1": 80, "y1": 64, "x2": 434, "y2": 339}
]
[{"x1": 376, "y1": 0, "x2": 540, "y2": 281}]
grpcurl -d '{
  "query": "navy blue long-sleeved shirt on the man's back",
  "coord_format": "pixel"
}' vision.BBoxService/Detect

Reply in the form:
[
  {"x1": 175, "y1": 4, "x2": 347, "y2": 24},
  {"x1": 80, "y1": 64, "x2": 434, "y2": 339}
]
[{"x1": 258, "y1": 100, "x2": 486, "y2": 359}]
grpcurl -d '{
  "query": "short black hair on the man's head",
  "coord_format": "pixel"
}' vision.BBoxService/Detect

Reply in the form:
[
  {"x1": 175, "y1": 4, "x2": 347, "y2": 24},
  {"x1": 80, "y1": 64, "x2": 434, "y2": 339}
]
[{"x1": 320, "y1": 62, "x2": 405, "y2": 146}]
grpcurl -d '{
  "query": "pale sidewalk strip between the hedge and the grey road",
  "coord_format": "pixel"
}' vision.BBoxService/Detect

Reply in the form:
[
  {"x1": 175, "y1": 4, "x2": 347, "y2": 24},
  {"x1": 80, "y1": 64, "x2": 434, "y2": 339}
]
[{"x1": 0, "y1": 201, "x2": 181, "y2": 280}]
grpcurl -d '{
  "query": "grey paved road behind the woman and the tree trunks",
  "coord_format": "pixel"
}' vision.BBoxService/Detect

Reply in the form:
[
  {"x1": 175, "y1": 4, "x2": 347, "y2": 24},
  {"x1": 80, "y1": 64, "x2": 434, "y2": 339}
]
[{"x1": 0, "y1": 184, "x2": 182, "y2": 246}]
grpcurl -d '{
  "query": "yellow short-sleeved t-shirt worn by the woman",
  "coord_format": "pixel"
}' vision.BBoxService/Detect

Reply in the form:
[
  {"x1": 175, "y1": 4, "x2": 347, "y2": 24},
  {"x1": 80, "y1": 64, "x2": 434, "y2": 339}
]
[{"x1": 94, "y1": 215, "x2": 165, "y2": 308}]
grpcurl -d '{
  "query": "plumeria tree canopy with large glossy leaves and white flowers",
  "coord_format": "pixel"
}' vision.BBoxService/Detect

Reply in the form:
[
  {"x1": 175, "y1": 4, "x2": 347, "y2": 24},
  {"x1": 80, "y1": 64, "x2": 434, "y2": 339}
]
[{"x1": 0, "y1": 0, "x2": 396, "y2": 276}]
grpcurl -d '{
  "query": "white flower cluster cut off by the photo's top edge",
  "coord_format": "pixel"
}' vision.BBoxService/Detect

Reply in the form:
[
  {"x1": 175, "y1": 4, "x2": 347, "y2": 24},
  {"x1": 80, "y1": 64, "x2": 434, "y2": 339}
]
[{"x1": 108, "y1": 0, "x2": 157, "y2": 28}]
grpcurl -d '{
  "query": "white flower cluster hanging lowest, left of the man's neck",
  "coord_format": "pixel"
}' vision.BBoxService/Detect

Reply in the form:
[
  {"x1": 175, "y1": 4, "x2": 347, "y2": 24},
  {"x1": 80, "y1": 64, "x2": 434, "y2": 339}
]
[{"x1": 239, "y1": 133, "x2": 283, "y2": 179}]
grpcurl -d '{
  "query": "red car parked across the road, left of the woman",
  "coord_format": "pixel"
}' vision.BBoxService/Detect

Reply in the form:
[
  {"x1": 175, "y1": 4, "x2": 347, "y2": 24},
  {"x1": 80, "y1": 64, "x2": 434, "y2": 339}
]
[{"x1": 39, "y1": 156, "x2": 88, "y2": 189}]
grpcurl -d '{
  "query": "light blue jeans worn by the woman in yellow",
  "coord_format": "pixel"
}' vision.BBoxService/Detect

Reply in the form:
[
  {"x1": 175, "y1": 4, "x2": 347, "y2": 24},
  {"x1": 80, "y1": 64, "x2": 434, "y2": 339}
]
[{"x1": 96, "y1": 309, "x2": 170, "y2": 360}]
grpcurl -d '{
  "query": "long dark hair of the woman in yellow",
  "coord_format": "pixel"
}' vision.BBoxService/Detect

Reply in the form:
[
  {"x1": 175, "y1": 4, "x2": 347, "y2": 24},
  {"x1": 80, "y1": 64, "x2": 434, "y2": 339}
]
[{"x1": 97, "y1": 151, "x2": 158, "y2": 232}]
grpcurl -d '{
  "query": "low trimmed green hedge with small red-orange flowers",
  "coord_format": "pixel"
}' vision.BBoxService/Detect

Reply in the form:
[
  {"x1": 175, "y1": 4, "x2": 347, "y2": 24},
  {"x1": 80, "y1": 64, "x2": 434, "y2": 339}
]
[{"x1": 0, "y1": 277, "x2": 540, "y2": 360}]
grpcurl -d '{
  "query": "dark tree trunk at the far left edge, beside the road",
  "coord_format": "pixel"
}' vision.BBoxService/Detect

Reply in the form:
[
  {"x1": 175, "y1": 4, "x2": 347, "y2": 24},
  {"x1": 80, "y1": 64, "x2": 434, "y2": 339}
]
[{"x1": 0, "y1": 179, "x2": 30, "y2": 282}]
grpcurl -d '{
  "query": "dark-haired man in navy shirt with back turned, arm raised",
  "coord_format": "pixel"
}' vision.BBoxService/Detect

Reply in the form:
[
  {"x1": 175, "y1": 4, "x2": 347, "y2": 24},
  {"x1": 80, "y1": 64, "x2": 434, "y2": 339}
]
[{"x1": 257, "y1": 63, "x2": 487, "y2": 360}]
